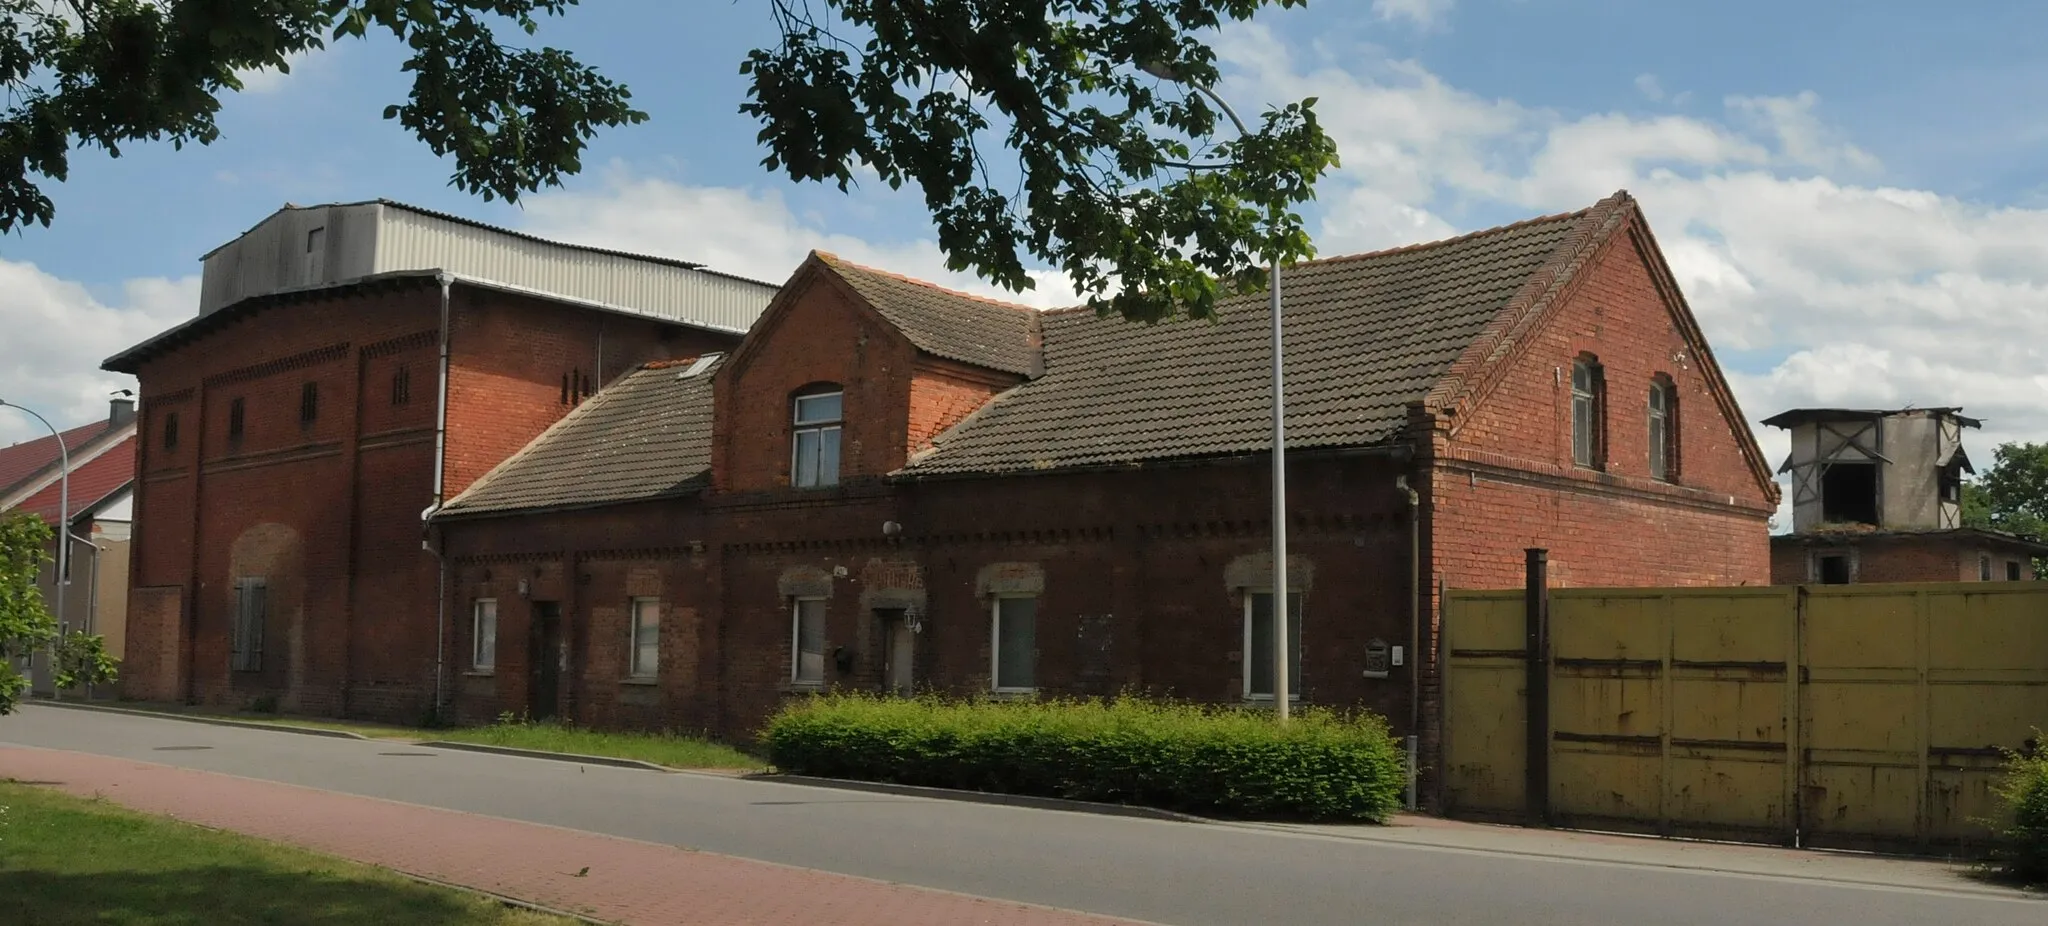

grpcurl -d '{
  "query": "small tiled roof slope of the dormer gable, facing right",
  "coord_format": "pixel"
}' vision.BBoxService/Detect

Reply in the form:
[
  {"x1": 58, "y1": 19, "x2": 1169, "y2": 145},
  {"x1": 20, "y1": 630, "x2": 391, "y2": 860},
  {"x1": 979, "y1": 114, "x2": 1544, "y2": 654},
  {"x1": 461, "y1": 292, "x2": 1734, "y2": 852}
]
[{"x1": 817, "y1": 254, "x2": 1038, "y2": 377}]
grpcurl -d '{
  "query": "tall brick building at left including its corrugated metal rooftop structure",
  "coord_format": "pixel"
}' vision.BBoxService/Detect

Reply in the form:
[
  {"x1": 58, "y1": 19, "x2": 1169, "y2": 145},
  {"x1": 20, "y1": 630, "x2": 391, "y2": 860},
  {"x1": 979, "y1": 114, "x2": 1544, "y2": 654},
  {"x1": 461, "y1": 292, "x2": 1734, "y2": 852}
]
[{"x1": 104, "y1": 201, "x2": 774, "y2": 721}]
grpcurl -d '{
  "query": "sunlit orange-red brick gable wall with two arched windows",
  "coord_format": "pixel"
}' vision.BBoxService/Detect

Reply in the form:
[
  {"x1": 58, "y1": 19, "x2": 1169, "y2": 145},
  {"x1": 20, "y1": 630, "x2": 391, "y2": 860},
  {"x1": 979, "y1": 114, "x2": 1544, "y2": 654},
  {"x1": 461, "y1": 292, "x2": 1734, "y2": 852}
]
[{"x1": 1415, "y1": 227, "x2": 1776, "y2": 811}]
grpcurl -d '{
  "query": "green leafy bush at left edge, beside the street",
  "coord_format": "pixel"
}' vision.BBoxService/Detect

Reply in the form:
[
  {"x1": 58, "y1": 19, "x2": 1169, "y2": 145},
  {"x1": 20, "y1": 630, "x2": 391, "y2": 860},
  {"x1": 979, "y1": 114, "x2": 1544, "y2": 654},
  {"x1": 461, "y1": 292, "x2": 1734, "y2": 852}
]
[{"x1": 0, "y1": 512, "x2": 117, "y2": 715}]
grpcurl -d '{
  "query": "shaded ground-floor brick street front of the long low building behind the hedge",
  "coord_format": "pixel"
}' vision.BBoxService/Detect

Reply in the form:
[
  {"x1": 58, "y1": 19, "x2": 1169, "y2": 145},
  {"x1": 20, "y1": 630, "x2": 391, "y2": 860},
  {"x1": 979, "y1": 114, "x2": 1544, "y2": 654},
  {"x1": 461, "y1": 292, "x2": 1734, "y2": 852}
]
[{"x1": 446, "y1": 459, "x2": 1409, "y2": 740}]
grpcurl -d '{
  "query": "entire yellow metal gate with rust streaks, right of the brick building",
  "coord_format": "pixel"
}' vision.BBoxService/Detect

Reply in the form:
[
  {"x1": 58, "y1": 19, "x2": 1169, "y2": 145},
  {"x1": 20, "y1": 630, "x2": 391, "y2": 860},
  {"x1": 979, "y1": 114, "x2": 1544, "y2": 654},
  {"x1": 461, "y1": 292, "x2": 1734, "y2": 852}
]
[{"x1": 1442, "y1": 584, "x2": 2048, "y2": 846}]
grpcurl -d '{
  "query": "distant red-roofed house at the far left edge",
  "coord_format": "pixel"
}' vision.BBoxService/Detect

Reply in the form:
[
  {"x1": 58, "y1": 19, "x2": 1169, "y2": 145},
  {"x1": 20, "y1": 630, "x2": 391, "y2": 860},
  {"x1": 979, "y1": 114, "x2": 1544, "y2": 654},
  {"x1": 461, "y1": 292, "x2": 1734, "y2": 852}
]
[{"x1": 0, "y1": 399, "x2": 135, "y2": 695}]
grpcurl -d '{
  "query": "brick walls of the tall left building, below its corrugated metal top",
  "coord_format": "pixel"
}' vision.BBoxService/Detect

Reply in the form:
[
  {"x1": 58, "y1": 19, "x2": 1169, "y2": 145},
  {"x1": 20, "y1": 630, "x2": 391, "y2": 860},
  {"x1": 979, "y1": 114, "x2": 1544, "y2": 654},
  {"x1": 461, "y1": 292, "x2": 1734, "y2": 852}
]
[{"x1": 127, "y1": 281, "x2": 735, "y2": 721}]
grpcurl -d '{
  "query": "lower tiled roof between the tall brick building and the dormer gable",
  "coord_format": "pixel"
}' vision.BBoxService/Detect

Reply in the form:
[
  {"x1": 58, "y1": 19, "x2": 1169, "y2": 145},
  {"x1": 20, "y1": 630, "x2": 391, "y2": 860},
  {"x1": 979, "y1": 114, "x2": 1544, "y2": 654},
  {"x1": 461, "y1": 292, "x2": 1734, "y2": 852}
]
[{"x1": 444, "y1": 359, "x2": 719, "y2": 516}]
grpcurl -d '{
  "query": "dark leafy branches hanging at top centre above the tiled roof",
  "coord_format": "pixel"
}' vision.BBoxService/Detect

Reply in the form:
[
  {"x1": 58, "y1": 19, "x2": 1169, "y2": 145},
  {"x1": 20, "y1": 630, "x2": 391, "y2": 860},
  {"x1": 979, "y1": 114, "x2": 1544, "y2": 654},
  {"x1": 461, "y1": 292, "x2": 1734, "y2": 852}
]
[{"x1": 741, "y1": 0, "x2": 1337, "y2": 322}]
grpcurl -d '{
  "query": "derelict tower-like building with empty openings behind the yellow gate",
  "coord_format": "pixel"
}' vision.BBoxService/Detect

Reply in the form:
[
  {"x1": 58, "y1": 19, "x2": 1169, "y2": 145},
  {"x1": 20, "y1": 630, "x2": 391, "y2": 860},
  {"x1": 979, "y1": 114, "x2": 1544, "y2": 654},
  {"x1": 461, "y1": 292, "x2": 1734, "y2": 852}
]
[{"x1": 1763, "y1": 408, "x2": 2048, "y2": 586}]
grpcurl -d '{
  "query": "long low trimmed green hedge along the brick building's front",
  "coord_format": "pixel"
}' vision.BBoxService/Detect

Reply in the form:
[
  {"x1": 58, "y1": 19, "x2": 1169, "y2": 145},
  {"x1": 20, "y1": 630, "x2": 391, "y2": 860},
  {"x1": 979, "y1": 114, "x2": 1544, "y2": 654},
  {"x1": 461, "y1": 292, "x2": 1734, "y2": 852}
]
[{"x1": 762, "y1": 695, "x2": 1405, "y2": 822}]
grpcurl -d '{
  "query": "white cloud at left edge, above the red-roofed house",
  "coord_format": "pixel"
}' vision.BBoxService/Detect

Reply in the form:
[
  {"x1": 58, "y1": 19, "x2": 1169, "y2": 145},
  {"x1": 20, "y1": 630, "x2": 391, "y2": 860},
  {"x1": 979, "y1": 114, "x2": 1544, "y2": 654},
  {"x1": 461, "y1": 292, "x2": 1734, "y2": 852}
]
[{"x1": 0, "y1": 260, "x2": 199, "y2": 445}]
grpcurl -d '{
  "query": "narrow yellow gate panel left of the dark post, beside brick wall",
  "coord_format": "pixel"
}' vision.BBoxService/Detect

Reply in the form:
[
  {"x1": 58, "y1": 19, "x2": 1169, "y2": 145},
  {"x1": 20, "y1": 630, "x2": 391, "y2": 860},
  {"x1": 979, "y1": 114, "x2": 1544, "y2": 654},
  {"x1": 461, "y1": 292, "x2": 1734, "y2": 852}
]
[{"x1": 1442, "y1": 592, "x2": 1528, "y2": 819}]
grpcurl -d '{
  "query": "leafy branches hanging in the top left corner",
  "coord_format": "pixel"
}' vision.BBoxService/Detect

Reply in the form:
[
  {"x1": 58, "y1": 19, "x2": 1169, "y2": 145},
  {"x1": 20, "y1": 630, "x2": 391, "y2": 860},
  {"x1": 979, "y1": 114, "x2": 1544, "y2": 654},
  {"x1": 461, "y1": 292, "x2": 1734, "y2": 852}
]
[{"x1": 0, "y1": 0, "x2": 647, "y2": 232}]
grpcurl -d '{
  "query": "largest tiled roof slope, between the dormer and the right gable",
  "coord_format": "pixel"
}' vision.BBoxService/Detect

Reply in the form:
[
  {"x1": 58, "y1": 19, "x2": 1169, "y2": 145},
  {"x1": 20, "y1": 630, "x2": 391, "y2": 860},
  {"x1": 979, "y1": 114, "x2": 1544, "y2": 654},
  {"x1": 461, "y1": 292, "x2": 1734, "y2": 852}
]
[{"x1": 903, "y1": 201, "x2": 1612, "y2": 475}]
